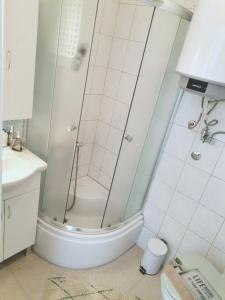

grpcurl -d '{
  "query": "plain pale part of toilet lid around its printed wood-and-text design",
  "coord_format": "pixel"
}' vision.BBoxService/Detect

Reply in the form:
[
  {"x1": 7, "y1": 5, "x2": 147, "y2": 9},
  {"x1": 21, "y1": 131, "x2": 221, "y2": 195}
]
[{"x1": 161, "y1": 255, "x2": 225, "y2": 300}]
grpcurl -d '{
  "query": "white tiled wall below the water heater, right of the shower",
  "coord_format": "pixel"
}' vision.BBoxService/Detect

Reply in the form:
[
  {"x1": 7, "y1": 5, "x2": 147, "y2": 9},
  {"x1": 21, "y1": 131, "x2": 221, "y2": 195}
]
[{"x1": 138, "y1": 93, "x2": 225, "y2": 271}]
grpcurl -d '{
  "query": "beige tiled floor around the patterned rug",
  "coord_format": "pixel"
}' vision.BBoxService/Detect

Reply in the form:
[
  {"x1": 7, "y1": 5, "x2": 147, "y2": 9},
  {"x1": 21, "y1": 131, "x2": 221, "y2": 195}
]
[{"x1": 0, "y1": 247, "x2": 161, "y2": 300}]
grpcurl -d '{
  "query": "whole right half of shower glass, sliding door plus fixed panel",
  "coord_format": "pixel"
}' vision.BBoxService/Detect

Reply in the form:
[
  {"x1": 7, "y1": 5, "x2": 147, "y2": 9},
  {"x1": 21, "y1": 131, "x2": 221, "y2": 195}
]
[{"x1": 103, "y1": 10, "x2": 188, "y2": 227}]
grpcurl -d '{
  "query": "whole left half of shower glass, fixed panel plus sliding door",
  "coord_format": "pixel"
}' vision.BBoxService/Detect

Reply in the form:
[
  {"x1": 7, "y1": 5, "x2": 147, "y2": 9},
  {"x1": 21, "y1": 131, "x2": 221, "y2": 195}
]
[{"x1": 28, "y1": 0, "x2": 98, "y2": 222}]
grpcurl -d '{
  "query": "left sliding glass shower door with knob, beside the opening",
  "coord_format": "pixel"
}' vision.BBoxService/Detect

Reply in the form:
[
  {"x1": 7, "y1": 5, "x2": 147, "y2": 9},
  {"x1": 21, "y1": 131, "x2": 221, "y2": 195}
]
[{"x1": 30, "y1": 0, "x2": 98, "y2": 222}]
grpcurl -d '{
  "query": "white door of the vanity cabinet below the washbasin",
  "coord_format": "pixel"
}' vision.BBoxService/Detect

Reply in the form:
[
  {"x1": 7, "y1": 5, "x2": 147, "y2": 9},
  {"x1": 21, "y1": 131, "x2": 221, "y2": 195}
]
[{"x1": 4, "y1": 190, "x2": 39, "y2": 259}]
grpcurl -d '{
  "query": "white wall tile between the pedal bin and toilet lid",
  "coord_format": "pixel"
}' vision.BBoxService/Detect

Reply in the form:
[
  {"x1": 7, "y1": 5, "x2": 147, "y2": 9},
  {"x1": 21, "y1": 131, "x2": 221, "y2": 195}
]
[{"x1": 179, "y1": 231, "x2": 210, "y2": 256}]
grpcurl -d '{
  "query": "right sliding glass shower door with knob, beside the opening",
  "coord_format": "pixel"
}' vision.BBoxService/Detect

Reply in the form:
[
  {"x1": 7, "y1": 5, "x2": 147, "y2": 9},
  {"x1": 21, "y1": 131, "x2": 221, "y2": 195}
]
[{"x1": 103, "y1": 9, "x2": 183, "y2": 227}]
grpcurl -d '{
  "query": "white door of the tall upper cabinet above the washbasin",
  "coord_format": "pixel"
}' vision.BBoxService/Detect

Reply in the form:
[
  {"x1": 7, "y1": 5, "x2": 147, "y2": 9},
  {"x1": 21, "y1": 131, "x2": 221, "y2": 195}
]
[{"x1": 3, "y1": 0, "x2": 39, "y2": 120}]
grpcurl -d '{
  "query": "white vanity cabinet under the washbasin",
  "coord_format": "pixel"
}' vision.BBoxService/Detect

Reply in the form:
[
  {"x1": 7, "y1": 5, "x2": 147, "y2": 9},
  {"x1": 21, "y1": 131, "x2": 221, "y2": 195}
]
[{"x1": 0, "y1": 173, "x2": 41, "y2": 261}]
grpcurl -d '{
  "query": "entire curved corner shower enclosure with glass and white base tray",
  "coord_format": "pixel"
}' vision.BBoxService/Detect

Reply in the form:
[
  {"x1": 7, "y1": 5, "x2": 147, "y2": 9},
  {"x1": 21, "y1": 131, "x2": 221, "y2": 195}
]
[{"x1": 27, "y1": 0, "x2": 191, "y2": 267}]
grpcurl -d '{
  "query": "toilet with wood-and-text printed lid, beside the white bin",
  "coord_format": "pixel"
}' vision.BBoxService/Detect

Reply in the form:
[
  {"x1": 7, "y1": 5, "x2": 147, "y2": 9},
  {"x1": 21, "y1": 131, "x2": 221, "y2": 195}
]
[{"x1": 161, "y1": 255, "x2": 225, "y2": 300}]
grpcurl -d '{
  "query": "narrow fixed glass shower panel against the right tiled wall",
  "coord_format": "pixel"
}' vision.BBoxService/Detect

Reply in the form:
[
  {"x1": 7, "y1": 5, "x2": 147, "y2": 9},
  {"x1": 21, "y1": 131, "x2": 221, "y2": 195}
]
[{"x1": 123, "y1": 20, "x2": 189, "y2": 221}]
